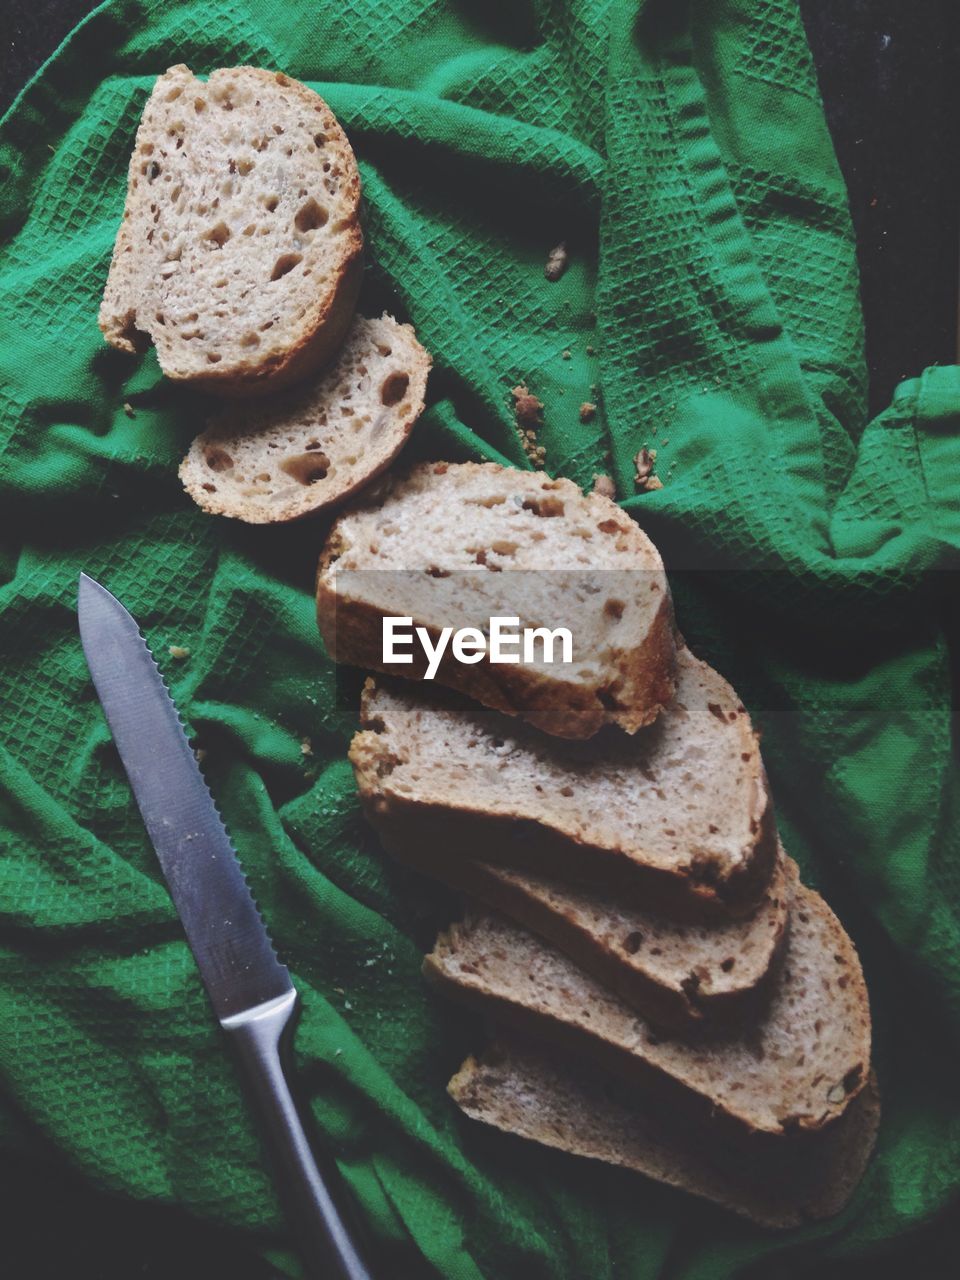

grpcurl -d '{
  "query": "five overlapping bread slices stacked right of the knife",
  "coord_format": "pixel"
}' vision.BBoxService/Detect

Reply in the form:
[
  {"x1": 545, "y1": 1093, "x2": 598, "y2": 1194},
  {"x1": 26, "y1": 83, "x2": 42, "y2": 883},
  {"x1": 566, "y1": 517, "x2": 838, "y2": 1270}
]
[{"x1": 317, "y1": 463, "x2": 878, "y2": 1226}]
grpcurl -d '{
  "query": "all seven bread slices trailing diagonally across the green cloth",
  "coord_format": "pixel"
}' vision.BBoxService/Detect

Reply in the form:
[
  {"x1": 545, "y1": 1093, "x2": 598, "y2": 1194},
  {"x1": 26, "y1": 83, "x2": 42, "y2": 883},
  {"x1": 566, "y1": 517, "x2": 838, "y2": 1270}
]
[{"x1": 100, "y1": 67, "x2": 878, "y2": 1226}]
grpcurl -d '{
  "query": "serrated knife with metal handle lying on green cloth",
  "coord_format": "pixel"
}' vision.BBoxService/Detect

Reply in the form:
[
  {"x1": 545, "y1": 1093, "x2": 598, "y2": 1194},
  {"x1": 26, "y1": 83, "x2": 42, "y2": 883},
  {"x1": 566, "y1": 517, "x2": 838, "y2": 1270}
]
[{"x1": 77, "y1": 573, "x2": 370, "y2": 1280}]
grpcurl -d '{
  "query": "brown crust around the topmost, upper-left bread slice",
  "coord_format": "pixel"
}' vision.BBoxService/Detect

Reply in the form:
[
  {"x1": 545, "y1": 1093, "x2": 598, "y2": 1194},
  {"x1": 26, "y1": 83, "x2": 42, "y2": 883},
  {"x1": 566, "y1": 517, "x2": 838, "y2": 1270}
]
[{"x1": 100, "y1": 64, "x2": 364, "y2": 397}]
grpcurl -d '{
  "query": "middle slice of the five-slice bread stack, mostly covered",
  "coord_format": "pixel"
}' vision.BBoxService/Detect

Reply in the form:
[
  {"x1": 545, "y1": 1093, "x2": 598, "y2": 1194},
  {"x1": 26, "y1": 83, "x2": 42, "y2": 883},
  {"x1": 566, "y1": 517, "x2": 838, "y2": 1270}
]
[{"x1": 393, "y1": 841, "x2": 787, "y2": 1030}]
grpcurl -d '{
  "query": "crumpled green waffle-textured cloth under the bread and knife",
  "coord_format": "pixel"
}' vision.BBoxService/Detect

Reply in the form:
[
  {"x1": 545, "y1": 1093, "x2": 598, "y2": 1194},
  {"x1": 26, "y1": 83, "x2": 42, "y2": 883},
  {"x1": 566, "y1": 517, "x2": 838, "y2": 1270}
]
[{"x1": 0, "y1": 0, "x2": 960, "y2": 1280}]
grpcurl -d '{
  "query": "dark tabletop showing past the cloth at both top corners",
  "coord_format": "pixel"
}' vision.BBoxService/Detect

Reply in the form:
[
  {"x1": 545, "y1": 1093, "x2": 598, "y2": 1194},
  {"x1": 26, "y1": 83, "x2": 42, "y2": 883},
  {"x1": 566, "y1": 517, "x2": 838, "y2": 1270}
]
[{"x1": 0, "y1": 0, "x2": 960, "y2": 413}]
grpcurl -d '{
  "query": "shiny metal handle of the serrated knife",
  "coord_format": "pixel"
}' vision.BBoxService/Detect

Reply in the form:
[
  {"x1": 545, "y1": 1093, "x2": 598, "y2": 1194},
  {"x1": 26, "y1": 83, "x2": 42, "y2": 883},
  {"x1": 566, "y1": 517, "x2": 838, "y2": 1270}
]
[{"x1": 220, "y1": 991, "x2": 371, "y2": 1280}]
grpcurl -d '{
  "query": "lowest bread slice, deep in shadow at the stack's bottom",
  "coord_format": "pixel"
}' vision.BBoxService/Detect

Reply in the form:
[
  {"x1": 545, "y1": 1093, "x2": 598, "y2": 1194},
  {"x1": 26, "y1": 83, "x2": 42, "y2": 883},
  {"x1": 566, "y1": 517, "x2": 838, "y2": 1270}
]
[{"x1": 448, "y1": 1038, "x2": 879, "y2": 1229}]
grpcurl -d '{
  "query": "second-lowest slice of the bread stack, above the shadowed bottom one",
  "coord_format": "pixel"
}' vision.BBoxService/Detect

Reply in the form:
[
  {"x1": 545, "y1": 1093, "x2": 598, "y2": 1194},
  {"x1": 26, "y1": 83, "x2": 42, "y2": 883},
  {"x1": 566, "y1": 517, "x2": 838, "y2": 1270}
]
[{"x1": 424, "y1": 860, "x2": 870, "y2": 1135}]
